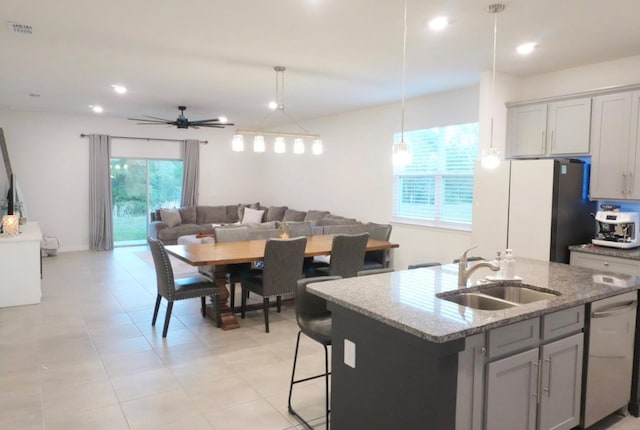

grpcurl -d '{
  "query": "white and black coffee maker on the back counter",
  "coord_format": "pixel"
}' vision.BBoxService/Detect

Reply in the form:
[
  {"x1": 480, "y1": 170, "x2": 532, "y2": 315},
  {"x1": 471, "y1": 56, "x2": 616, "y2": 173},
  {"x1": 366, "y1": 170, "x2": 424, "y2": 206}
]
[{"x1": 591, "y1": 210, "x2": 640, "y2": 249}]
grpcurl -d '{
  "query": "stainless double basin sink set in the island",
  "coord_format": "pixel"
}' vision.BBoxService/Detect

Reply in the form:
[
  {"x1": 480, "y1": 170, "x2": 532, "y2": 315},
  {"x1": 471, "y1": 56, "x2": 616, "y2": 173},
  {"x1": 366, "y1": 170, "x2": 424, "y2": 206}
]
[{"x1": 437, "y1": 282, "x2": 560, "y2": 311}]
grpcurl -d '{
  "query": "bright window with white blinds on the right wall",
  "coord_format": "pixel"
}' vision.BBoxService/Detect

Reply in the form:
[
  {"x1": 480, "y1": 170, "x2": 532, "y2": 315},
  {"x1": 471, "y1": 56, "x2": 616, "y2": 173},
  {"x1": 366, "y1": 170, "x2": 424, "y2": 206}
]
[{"x1": 393, "y1": 122, "x2": 478, "y2": 228}]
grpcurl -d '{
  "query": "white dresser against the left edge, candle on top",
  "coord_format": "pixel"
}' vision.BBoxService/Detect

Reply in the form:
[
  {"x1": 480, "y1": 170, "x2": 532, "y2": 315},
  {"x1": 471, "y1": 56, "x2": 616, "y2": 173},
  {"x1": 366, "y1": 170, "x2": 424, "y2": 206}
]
[{"x1": 0, "y1": 222, "x2": 42, "y2": 307}]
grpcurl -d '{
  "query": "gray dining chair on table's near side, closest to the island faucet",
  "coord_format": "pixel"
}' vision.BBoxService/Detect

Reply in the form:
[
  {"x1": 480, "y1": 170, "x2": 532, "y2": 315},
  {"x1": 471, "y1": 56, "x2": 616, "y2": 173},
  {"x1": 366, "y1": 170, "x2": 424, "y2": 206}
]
[{"x1": 306, "y1": 233, "x2": 369, "y2": 278}]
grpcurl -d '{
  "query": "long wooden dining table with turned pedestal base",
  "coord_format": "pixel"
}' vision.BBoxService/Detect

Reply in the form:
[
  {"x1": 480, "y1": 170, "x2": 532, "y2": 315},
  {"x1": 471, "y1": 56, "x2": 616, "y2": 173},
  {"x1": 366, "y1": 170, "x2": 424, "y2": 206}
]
[{"x1": 165, "y1": 235, "x2": 399, "y2": 330}]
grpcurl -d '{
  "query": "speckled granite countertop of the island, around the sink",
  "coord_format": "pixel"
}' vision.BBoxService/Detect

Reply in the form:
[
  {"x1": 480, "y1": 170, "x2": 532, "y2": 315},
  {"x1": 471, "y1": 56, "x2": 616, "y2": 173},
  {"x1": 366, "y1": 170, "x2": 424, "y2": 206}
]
[{"x1": 308, "y1": 258, "x2": 640, "y2": 343}]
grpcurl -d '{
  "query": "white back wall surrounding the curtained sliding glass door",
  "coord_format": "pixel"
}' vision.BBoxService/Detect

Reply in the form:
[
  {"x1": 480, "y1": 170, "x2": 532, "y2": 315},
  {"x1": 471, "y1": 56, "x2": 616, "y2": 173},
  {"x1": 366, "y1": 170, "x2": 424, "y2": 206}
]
[{"x1": 0, "y1": 110, "x2": 262, "y2": 252}]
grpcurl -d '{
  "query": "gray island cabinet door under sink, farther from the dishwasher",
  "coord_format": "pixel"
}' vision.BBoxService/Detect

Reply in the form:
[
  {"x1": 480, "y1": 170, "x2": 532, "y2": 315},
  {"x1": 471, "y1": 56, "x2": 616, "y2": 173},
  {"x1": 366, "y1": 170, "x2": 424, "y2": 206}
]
[{"x1": 484, "y1": 348, "x2": 539, "y2": 430}]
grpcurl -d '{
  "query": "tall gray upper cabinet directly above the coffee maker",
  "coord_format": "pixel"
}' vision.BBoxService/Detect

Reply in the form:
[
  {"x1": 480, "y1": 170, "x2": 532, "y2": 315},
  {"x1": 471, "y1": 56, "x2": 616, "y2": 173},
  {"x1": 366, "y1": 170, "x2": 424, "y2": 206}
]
[{"x1": 590, "y1": 91, "x2": 640, "y2": 200}]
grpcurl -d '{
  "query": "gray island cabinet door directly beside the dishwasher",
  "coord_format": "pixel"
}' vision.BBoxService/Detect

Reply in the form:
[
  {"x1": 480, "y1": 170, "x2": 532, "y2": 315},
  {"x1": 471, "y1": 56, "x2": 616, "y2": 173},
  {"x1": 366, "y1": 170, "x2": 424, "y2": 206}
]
[{"x1": 538, "y1": 333, "x2": 584, "y2": 430}]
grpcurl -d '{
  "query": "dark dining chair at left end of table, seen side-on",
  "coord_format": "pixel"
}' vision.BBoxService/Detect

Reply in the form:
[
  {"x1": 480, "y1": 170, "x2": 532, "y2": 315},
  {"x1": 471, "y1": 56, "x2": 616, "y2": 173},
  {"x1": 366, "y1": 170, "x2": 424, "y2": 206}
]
[{"x1": 147, "y1": 237, "x2": 218, "y2": 337}]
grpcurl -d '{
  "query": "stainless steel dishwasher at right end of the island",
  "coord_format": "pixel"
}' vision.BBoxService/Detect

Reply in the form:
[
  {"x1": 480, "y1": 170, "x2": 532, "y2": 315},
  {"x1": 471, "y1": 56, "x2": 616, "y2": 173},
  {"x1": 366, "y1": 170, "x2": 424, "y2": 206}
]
[{"x1": 581, "y1": 292, "x2": 638, "y2": 428}]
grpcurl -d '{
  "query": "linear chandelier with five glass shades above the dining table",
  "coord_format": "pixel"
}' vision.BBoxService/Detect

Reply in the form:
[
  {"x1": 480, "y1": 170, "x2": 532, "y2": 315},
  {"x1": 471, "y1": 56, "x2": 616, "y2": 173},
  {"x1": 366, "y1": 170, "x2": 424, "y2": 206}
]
[{"x1": 231, "y1": 66, "x2": 323, "y2": 155}]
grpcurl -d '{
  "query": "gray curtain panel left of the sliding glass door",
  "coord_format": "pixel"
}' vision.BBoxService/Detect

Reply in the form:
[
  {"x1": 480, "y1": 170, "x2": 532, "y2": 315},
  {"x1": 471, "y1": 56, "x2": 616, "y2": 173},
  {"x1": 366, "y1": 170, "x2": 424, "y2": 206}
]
[{"x1": 89, "y1": 134, "x2": 113, "y2": 251}]
